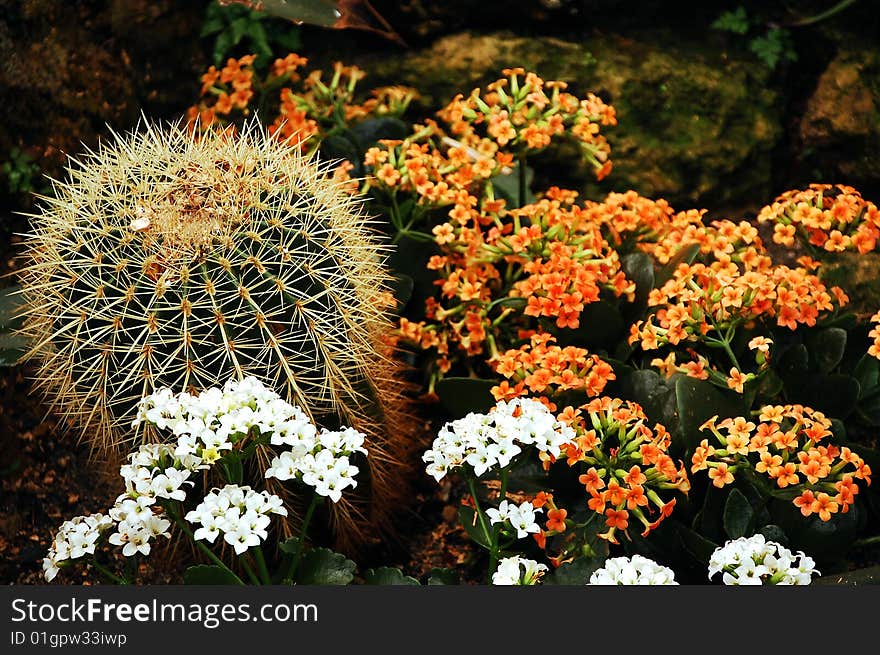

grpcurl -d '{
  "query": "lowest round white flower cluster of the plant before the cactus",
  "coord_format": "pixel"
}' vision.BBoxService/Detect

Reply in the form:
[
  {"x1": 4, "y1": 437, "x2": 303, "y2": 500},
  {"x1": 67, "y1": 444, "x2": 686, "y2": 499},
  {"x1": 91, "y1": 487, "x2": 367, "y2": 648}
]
[{"x1": 186, "y1": 484, "x2": 287, "y2": 555}]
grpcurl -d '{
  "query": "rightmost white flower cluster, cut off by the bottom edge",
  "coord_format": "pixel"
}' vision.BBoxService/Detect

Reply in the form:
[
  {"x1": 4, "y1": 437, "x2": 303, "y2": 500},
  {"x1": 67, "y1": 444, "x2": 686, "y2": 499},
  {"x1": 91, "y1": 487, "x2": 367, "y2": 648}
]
[{"x1": 709, "y1": 534, "x2": 819, "y2": 585}]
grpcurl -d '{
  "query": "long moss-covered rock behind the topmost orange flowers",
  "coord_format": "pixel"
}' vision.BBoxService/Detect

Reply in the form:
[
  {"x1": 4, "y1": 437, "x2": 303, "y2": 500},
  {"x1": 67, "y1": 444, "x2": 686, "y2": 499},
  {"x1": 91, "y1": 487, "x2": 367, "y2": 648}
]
[{"x1": 334, "y1": 32, "x2": 782, "y2": 208}]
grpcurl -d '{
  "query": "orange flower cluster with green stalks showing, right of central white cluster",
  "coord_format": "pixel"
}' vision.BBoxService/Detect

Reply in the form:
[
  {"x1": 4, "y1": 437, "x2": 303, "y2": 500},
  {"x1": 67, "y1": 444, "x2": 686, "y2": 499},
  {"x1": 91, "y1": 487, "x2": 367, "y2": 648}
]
[{"x1": 542, "y1": 397, "x2": 690, "y2": 543}]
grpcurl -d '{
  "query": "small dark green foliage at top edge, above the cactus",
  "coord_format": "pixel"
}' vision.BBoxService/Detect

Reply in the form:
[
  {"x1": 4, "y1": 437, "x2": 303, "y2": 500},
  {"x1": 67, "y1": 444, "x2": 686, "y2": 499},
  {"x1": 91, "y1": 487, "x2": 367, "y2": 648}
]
[{"x1": 201, "y1": 1, "x2": 301, "y2": 68}]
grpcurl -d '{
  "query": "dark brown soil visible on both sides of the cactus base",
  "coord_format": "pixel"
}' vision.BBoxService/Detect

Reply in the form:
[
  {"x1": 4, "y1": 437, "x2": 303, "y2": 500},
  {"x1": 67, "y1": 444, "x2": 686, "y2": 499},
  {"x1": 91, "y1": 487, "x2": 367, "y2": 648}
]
[{"x1": 0, "y1": 366, "x2": 475, "y2": 584}]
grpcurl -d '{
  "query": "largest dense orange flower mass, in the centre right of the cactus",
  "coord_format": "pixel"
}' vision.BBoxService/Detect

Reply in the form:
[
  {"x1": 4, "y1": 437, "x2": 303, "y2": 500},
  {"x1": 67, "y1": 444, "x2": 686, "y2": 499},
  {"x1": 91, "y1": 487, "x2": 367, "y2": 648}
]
[{"x1": 399, "y1": 188, "x2": 635, "y2": 394}]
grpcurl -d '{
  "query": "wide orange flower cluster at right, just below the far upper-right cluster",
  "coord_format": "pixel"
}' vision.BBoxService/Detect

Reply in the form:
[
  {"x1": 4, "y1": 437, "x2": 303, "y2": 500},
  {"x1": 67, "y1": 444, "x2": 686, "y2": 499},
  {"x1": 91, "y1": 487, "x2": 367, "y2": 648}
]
[{"x1": 629, "y1": 258, "x2": 848, "y2": 350}]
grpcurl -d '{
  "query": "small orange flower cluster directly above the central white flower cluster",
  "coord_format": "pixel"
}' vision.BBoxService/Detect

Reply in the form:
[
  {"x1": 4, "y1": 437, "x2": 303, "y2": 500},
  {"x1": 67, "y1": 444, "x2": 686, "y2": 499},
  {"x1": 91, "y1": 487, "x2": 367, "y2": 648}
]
[{"x1": 491, "y1": 332, "x2": 615, "y2": 401}]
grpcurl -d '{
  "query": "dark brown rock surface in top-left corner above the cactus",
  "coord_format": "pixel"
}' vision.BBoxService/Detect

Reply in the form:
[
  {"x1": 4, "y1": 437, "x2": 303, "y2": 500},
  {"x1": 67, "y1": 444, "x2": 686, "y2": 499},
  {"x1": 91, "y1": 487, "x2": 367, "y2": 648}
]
[{"x1": 0, "y1": 0, "x2": 205, "y2": 173}]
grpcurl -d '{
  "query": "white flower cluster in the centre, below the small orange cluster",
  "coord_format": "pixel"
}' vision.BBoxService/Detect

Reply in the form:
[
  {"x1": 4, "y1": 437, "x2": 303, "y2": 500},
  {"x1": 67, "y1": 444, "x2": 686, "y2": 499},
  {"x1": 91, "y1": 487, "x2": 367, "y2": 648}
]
[{"x1": 422, "y1": 398, "x2": 575, "y2": 482}]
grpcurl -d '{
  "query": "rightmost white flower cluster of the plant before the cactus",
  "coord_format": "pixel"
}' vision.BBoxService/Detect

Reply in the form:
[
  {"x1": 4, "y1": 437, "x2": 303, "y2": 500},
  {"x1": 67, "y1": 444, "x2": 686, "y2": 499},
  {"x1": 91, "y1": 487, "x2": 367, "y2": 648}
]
[{"x1": 266, "y1": 424, "x2": 367, "y2": 503}]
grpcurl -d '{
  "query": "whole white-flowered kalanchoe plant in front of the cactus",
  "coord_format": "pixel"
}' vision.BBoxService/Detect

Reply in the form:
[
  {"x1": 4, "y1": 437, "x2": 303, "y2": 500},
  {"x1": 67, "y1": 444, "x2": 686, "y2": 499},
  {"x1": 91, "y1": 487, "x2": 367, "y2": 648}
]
[{"x1": 43, "y1": 377, "x2": 367, "y2": 584}]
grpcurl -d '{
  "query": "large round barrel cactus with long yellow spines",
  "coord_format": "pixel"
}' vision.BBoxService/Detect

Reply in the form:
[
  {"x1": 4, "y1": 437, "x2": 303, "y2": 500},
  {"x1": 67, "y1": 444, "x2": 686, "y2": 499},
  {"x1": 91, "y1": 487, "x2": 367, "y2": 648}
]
[{"x1": 22, "y1": 123, "x2": 412, "y2": 535}]
